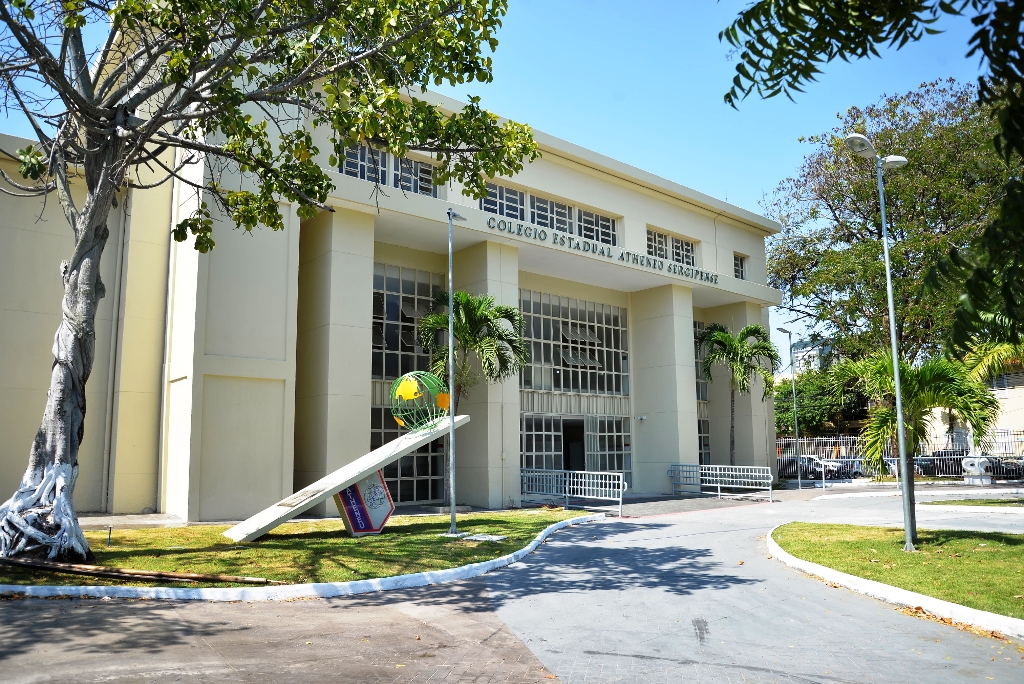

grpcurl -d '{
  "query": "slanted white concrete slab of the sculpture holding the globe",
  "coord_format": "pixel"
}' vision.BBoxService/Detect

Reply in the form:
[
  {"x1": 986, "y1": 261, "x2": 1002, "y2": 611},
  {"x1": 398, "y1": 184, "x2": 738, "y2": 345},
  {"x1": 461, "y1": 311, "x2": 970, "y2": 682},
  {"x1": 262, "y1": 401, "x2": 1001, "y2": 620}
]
[{"x1": 224, "y1": 416, "x2": 469, "y2": 542}]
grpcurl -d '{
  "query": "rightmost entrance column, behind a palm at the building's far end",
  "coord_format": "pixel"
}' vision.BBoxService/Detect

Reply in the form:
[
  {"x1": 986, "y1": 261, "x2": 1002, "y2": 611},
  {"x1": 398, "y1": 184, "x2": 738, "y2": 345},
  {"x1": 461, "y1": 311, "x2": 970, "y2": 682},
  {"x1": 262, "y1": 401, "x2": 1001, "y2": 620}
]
[{"x1": 705, "y1": 302, "x2": 775, "y2": 470}]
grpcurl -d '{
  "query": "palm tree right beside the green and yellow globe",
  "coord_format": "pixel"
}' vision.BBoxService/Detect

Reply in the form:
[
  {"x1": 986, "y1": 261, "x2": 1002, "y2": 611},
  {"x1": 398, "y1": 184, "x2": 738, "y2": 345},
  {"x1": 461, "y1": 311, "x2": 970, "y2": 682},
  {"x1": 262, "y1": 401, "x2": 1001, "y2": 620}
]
[{"x1": 419, "y1": 291, "x2": 529, "y2": 506}]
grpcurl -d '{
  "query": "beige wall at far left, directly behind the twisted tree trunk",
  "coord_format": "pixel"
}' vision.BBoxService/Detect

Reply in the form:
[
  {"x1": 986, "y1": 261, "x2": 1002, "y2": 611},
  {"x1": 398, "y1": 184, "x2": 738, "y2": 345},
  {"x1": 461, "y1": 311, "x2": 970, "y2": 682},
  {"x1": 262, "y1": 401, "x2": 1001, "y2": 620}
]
[{"x1": 0, "y1": 152, "x2": 124, "y2": 511}]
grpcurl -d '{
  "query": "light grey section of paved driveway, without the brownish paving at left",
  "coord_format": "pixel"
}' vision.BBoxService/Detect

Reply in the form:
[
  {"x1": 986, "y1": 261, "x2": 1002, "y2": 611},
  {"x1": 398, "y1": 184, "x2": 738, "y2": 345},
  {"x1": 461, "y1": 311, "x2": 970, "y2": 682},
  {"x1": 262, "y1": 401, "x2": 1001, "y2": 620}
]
[{"x1": 487, "y1": 497, "x2": 1024, "y2": 683}]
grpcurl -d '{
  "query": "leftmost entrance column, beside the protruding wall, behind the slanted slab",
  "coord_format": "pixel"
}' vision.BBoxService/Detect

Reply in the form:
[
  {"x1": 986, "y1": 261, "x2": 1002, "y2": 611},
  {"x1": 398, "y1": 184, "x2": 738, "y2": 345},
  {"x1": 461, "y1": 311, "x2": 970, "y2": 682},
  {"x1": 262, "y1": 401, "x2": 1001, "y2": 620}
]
[{"x1": 295, "y1": 209, "x2": 374, "y2": 515}]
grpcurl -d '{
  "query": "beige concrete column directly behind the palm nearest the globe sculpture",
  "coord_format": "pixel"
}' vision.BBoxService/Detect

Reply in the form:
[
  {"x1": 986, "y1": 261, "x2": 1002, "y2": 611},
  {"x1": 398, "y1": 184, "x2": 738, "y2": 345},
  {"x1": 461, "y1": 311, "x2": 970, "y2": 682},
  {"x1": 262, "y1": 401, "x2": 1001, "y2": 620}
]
[{"x1": 453, "y1": 242, "x2": 520, "y2": 508}]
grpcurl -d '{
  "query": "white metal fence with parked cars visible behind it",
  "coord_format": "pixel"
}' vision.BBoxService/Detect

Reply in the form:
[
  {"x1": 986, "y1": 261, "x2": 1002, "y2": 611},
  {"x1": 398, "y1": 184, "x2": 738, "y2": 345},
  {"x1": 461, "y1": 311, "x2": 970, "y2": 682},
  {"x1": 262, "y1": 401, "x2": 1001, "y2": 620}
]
[{"x1": 776, "y1": 430, "x2": 1024, "y2": 480}]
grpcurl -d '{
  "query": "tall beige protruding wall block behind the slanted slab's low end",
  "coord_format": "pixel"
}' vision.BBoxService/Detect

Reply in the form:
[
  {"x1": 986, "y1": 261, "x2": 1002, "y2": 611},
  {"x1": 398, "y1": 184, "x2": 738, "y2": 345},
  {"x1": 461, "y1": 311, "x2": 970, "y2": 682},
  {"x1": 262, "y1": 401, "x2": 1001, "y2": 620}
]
[{"x1": 162, "y1": 189, "x2": 299, "y2": 520}]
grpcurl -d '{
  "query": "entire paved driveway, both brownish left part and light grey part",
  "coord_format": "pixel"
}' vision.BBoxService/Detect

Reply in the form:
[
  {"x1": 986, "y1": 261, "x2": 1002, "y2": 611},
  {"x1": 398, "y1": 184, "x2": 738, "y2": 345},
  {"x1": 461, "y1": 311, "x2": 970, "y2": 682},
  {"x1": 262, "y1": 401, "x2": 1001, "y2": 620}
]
[{"x1": 0, "y1": 497, "x2": 1024, "y2": 684}]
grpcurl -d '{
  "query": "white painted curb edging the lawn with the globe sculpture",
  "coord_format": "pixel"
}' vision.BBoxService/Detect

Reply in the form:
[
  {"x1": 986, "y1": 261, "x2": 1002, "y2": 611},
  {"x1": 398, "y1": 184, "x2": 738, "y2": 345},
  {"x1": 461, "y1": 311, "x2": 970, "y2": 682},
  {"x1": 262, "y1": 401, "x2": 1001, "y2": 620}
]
[{"x1": 0, "y1": 513, "x2": 604, "y2": 601}]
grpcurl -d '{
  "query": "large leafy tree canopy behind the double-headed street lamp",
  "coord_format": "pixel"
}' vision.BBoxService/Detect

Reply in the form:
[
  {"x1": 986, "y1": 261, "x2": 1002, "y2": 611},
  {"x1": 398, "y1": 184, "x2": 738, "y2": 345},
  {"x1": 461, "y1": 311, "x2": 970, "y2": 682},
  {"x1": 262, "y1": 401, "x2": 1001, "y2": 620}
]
[{"x1": 765, "y1": 80, "x2": 1012, "y2": 359}]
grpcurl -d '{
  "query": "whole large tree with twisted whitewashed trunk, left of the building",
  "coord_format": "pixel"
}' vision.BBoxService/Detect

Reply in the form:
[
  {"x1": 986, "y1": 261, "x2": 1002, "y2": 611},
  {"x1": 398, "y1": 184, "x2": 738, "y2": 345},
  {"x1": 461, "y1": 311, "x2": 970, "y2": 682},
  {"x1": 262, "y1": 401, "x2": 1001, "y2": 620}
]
[{"x1": 0, "y1": 0, "x2": 539, "y2": 560}]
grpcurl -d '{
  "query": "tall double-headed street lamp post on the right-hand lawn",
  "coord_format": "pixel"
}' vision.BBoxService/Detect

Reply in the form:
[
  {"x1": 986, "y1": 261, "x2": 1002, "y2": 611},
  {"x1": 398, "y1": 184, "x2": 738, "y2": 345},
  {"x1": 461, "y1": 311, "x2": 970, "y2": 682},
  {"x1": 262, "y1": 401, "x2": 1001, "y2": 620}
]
[{"x1": 845, "y1": 133, "x2": 918, "y2": 551}]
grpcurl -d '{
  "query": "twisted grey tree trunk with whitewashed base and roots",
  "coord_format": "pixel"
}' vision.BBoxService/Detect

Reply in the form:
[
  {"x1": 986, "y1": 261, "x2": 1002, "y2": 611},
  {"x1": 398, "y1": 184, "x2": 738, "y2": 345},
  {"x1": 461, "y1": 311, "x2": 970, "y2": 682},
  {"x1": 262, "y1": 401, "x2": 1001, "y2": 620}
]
[{"x1": 0, "y1": 138, "x2": 122, "y2": 561}]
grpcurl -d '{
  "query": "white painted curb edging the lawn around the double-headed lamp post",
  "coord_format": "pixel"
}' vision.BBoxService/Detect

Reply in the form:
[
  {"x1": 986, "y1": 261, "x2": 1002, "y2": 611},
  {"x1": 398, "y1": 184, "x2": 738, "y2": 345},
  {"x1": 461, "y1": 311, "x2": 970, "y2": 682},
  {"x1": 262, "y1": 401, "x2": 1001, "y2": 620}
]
[{"x1": 766, "y1": 525, "x2": 1024, "y2": 639}]
